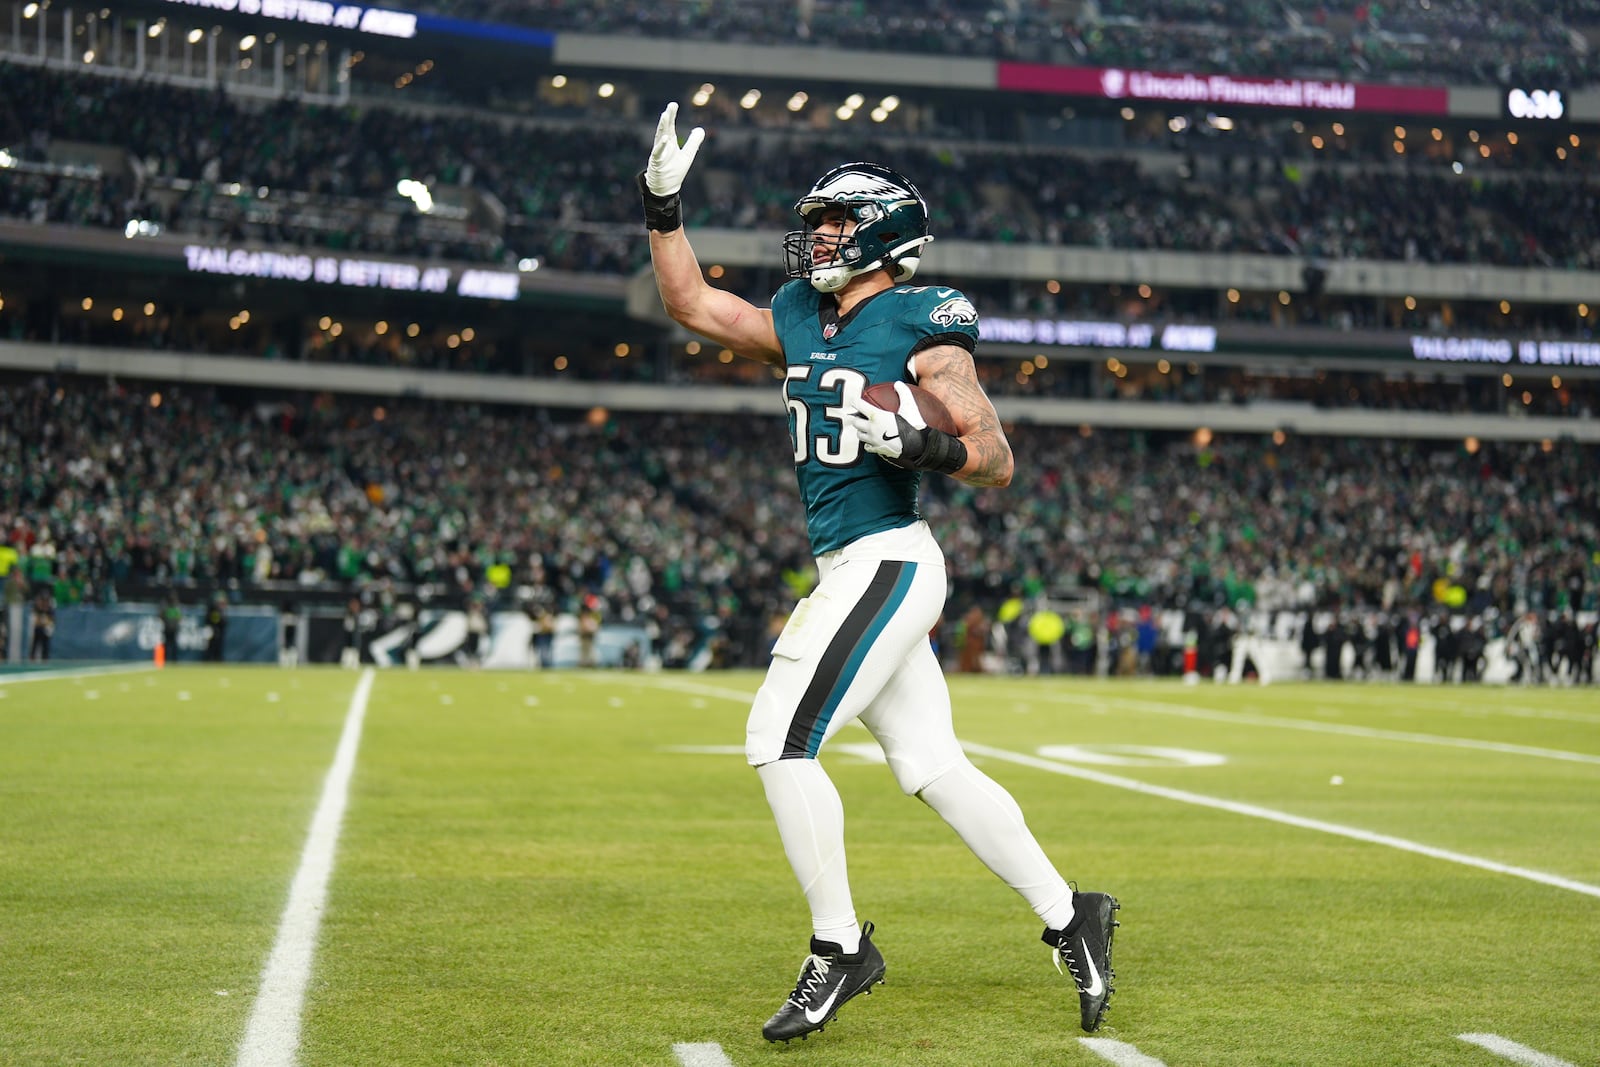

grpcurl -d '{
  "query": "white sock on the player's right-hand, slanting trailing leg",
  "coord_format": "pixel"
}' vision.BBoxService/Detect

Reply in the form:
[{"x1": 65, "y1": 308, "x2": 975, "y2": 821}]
[{"x1": 917, "y1": 760, "x2": 1072, "y2": 929}]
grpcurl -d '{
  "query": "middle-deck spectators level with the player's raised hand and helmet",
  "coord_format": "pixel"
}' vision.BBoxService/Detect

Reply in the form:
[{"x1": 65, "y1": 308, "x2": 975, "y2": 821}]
[{"x1": 0, "y1": 66, "x2": 1600, "y2": 274}]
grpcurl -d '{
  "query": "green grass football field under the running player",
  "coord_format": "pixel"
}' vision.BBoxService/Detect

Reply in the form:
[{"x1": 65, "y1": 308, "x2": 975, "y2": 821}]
[{"x1": 0, "y1": 667, "x2": 1600, "y2": 1067}]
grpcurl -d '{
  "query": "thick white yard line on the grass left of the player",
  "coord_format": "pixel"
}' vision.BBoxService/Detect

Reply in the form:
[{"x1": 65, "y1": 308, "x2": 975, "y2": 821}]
[{"x1": 238, "y1": 667, "x2": 376, "y2": 1067}]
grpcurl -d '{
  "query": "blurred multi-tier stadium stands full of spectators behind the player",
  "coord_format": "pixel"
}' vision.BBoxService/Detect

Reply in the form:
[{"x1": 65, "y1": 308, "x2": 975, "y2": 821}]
[{"x1": 0, "y1": 0, "x2": 1600, "y2": 678}]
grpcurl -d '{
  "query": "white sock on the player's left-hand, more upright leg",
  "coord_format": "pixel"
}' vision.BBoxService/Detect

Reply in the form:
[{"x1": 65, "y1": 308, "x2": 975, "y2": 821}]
[{"x1": 755, "y1": 760, "x2": 861, "y2": 953}]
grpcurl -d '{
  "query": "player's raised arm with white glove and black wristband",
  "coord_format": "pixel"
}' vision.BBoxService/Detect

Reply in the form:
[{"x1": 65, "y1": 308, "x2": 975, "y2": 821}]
[{"x1": 638, "y1": 104, "x2": 784, "y2": 365}]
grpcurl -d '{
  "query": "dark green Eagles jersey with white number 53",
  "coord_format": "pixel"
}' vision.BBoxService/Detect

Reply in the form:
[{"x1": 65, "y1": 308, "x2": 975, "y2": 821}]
[{"x1": 773, "y1": 280, "x2": 978, "y2": 555}]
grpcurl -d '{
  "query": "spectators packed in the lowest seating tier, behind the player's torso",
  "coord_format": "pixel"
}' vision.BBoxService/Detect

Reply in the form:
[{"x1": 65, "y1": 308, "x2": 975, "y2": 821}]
[{"x1": 0, "y1": 379, "x2": 1600, "y2": 664}]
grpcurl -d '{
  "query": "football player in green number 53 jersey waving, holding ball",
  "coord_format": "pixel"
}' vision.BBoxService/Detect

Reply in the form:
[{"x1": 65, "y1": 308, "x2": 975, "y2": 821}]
[{"x1": 638, "y1": 104, "x2": 1118, "y2": 1041}]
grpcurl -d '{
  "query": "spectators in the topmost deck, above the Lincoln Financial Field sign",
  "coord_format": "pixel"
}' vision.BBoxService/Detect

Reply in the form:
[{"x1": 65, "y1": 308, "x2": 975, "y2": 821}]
[{"x1": 396, "y1": 0, "x2": 1600, "y2": 86}]
